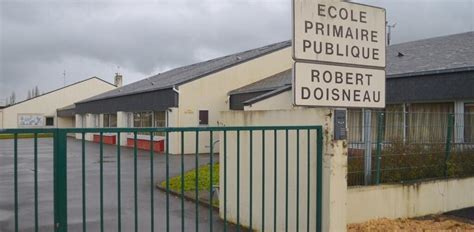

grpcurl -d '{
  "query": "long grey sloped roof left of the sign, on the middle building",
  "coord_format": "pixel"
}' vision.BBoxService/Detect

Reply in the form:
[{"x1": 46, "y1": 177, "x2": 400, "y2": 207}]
[{"x1": 80, "y1": 41, "x2": 291, "y2": 103}]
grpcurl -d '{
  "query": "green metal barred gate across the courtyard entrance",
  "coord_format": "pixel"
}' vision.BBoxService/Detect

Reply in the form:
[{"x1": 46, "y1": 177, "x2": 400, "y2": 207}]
[{"x1": 0, "y1": 126, "x2": 323, "y2": 232}]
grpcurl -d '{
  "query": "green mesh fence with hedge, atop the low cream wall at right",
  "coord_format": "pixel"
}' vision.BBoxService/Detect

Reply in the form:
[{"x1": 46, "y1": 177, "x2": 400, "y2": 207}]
[{"x1": 348, "y1": 111, "x2": 474, "y2": 186}]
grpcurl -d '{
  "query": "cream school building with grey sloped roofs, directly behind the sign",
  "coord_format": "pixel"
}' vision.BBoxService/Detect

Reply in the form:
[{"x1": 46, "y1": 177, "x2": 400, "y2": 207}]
[{"x1": 67, "y1": 32, "x2": 474, "y2": 153}]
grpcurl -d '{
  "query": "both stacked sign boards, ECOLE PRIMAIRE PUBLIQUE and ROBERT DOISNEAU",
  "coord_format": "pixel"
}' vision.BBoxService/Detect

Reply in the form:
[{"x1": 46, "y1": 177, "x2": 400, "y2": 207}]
[{"x1": 293, "y1": 0, "x2": 385, "y2": 108}]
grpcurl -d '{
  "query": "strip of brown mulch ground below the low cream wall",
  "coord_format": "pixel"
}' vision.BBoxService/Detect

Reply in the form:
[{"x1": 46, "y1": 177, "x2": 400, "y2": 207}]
[{"x1": 347, "y1": 215, "x2": 474, "y2": 232}]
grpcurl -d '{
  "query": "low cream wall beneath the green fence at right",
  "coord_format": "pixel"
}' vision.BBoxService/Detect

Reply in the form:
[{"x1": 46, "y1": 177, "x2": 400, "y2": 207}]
[{"x1": 347, "y1": 177, "x2": 474, "y2": 223}]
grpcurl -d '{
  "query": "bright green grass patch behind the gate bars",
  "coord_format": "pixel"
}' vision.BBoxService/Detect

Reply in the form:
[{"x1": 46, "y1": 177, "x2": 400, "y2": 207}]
[{"x1": 160, "y1": 163, "x2": 219, "y2": 192}]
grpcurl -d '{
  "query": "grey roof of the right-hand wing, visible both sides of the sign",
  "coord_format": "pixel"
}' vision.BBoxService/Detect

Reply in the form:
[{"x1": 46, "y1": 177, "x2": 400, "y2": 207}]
[{"x1": 229, "y1": 32, "x2": 474, "y2": 95}]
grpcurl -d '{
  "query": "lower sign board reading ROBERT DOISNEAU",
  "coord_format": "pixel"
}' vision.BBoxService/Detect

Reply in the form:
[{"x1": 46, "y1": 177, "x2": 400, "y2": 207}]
[{"x1": 293, "y1": 63, "x2": 385, "y2": 108}]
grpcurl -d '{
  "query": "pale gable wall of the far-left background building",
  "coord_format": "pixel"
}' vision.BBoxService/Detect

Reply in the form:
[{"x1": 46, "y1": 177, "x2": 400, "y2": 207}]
[{"x1": 3, "y1": 78, "x2": 115, "y2": 128}]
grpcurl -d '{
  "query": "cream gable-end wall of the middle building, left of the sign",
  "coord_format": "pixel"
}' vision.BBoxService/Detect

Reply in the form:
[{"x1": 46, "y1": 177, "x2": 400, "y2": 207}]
[{"x1": 175, "y1": 48, "x2": 293, "y2": 153}]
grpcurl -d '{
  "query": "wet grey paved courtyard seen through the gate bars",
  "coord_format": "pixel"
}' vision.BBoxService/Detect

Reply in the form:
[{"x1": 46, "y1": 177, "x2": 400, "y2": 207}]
[{"x1": 0, "y1": 138, "x2": 233, "y2": 232}]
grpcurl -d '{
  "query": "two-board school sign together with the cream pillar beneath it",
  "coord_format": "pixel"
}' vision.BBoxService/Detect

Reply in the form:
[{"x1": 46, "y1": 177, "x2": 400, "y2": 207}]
[{"x1": 293, "y1": 0, "x2": 386, "y2": 231}]
